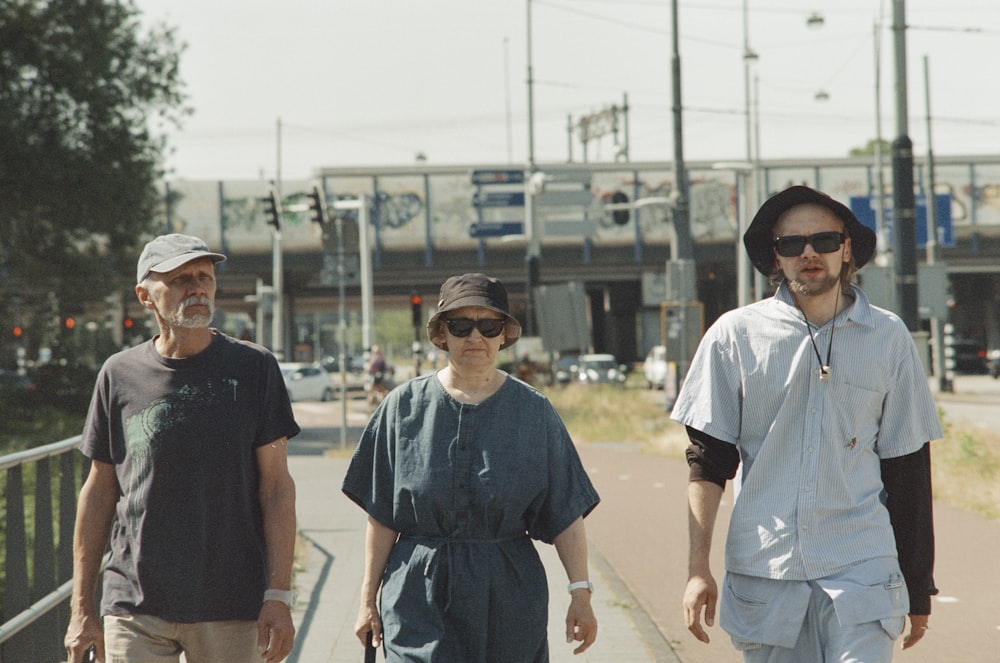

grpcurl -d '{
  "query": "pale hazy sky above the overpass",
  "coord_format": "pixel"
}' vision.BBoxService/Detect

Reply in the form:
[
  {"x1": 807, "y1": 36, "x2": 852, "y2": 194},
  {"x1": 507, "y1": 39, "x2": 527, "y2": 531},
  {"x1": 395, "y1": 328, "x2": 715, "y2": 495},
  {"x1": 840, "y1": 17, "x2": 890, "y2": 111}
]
[{"x1": 134, "y1": 0, "x2": 1000, "y2": 180}]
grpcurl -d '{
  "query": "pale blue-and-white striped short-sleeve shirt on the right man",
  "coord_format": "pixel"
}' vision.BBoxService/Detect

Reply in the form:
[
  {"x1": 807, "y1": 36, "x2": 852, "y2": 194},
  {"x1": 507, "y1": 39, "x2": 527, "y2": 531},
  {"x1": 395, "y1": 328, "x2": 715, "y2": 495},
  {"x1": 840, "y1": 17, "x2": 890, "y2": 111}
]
[{"x1": 672, "y1": 283, "x2": 943, "y2": 580}]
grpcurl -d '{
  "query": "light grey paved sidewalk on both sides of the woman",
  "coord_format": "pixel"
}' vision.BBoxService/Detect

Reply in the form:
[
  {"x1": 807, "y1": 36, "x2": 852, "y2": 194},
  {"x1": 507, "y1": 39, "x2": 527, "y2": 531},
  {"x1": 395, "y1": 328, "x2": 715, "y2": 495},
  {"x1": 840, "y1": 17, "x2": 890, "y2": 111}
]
[{"x1": 287, "y1": 407, "x2": 678, "y2": 663}]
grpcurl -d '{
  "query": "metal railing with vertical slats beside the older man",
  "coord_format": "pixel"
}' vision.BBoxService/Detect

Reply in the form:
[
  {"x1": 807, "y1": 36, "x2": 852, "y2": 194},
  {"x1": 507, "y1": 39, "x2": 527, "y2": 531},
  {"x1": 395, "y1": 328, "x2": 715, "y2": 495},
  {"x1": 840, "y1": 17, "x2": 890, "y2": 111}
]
[{"x1": 0, "y1": 435, "x2": 89, "y2": 663}]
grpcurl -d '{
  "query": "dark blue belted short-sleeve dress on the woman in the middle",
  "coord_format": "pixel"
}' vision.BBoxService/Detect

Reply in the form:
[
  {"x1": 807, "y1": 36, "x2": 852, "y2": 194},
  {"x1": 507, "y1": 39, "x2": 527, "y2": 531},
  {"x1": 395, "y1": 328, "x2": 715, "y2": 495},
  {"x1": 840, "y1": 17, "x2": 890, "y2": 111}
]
[{"x1": 343, "y1": 376, "x2": 599, "y2": 663}]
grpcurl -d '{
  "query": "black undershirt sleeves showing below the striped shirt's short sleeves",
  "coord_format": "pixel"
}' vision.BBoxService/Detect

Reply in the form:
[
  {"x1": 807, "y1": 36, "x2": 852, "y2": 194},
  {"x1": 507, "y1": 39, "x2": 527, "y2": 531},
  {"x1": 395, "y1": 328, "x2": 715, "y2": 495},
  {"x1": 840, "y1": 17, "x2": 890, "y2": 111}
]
[{"x1": 685, "y1": 426, "x2": 938, "y2": 615}]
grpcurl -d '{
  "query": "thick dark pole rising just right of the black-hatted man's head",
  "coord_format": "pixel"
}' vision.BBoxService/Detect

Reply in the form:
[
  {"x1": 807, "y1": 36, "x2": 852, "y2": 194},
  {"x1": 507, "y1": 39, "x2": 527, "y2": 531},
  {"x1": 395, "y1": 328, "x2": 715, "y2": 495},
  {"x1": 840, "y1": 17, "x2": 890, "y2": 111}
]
[{"x1": 892, "y1": 0, "x2": 920, "y2": 331}]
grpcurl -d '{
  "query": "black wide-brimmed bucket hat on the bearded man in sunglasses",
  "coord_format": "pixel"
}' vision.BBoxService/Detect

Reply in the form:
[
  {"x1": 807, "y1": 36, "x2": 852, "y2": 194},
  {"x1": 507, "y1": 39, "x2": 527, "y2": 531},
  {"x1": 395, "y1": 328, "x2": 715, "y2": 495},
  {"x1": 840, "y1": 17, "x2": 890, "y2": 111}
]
[{"x1": 743, "y1": 186, "x2": 875, "y2": 276}]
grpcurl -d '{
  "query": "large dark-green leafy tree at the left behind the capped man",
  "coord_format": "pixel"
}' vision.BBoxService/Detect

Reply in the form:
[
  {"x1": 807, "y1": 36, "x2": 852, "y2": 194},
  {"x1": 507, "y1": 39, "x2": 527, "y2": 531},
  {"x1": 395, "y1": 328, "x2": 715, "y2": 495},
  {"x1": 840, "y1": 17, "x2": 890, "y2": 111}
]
[{"x1": 0, "y1": 0, "x2": 188, "y2": 358}]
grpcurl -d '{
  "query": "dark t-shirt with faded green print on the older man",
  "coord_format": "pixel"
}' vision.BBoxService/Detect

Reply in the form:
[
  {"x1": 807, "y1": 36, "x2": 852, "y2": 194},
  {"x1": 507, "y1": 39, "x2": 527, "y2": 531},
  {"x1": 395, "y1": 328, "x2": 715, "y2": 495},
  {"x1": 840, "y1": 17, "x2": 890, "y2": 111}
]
[{"x1": 80, "y1": 332, "x2": 299, "y2": 623}]
